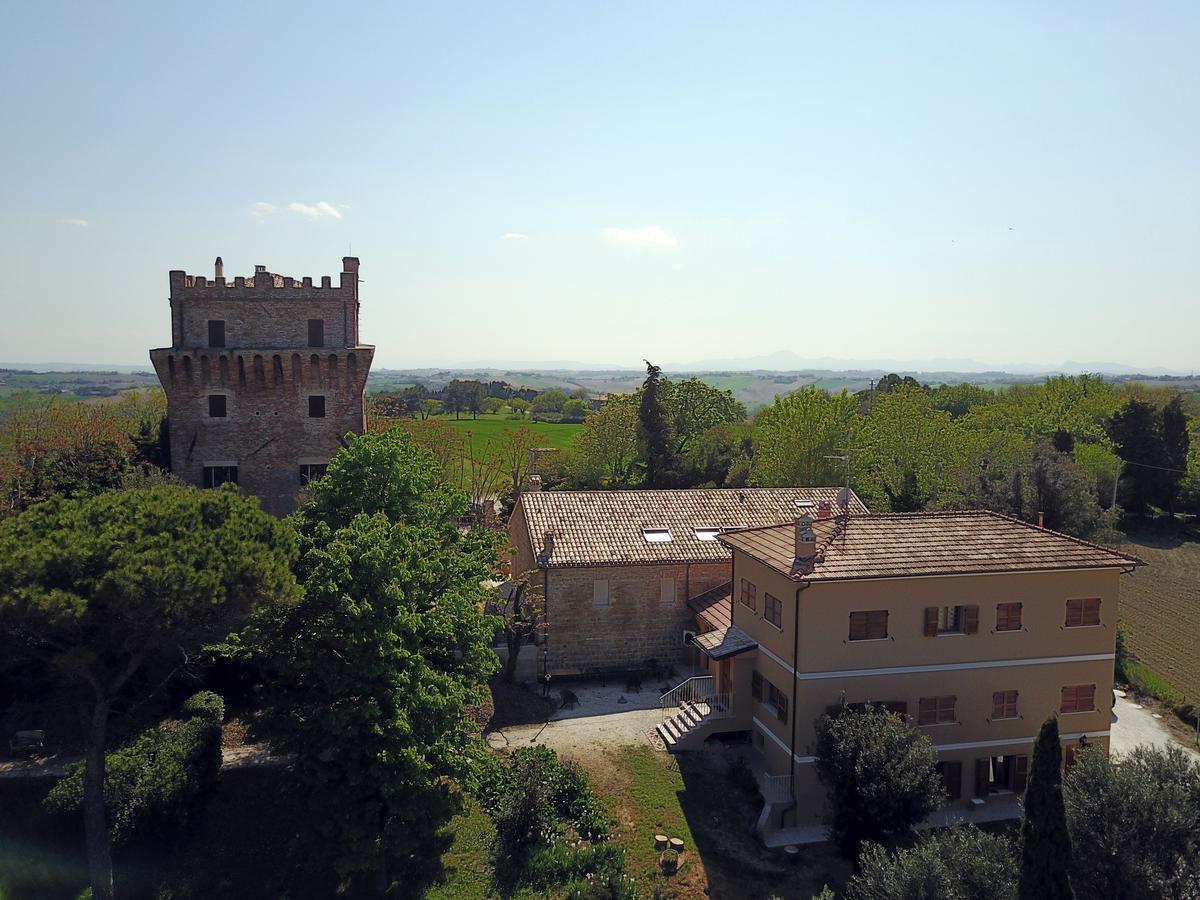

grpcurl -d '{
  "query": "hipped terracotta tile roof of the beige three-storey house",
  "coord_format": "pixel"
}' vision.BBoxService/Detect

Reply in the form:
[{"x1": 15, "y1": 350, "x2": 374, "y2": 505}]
[{"x1": 720, "y1": 510, "x2": 1145, "y2": 581}]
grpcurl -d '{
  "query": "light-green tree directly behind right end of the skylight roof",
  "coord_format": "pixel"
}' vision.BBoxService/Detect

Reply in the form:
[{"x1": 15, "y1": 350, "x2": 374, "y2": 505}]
[{"x1": 754, "y1": 388, "x2": 858, "y2": 487}]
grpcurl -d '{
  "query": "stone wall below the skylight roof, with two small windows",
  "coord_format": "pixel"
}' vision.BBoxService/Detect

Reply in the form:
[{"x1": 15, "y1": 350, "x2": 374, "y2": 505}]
[{"x1": 546, "y1": 563, "x2": 730, "y2": 673}]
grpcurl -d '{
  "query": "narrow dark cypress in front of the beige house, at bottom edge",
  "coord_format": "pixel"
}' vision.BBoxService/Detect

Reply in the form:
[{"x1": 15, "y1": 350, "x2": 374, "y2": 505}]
[{"x1": 1018, "y1": 715, "x2": 1075, "y2": 900}]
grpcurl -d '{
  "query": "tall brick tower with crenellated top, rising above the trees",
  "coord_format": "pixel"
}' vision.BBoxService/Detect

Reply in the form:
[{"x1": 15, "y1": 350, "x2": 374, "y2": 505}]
[{"x1": 150, "y1": 257, "x2": 374, "y2": 516}]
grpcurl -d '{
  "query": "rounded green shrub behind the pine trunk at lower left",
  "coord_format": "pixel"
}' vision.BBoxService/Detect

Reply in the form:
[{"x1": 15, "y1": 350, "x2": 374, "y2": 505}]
[{"x1": 44, "y1": 692, "x2": 224, "y2": 844}]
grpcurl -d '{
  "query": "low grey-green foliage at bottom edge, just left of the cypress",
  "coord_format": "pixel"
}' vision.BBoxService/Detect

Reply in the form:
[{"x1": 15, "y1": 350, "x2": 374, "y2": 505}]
[{"x1": 842, "y1": 824, "x2": 1016, "y2": 900}]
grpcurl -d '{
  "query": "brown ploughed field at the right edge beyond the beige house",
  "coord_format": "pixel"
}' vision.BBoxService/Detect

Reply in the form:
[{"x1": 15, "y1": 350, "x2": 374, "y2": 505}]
[{"x1": 1121, "y1": 526, "x2": 1200, "y2": 702}]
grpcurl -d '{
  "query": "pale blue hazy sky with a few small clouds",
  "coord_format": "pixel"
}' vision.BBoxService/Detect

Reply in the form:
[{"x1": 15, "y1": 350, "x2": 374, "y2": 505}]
[{"x1": 0, "y1": 0, "x2": 1200, "y2": 368}]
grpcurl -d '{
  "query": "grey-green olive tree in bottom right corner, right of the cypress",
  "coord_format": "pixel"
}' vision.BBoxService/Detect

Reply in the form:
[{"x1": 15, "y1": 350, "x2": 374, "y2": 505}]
[{"x1": 1063, "y1": 745, "x2": 1200, "y2": 900}]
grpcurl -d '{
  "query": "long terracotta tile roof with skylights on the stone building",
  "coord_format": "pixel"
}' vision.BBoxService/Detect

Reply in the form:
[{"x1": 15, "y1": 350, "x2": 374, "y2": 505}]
[{"x1": 512, "y1": 487, "x2": 866, "y2": 568}]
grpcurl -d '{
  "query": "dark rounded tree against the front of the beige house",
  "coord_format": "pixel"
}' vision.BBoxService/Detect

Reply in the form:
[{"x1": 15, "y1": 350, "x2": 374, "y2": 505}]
[{"x1": 816, "y1": 706, "x2": 946, "y2": 856}]
